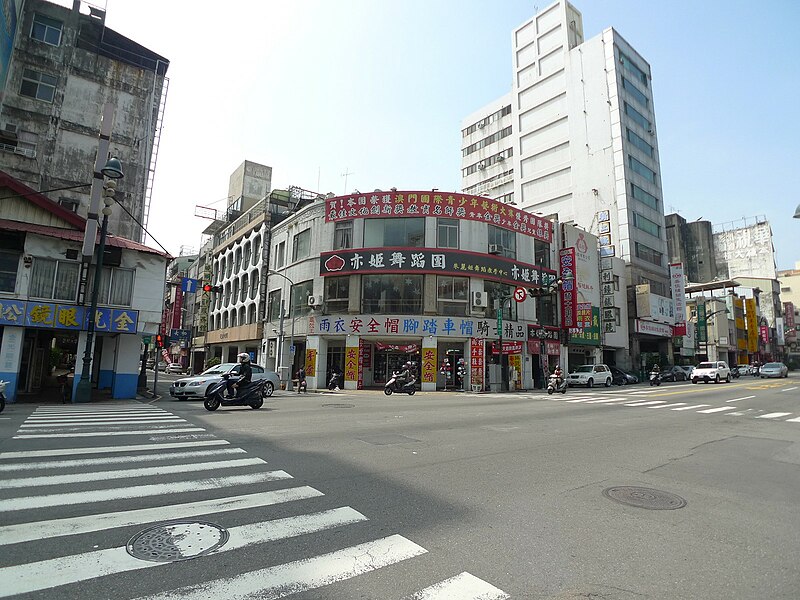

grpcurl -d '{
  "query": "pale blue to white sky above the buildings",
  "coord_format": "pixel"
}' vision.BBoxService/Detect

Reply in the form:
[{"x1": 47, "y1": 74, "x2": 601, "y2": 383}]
[{"x1": 101, "y1": 0, "x2": 800, "y2": 269}]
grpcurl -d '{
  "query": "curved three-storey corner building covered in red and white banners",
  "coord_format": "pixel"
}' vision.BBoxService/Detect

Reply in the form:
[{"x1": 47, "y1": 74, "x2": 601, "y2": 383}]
[{"x1": 264, "y1": 190, "x2": 561, "y2": 390}]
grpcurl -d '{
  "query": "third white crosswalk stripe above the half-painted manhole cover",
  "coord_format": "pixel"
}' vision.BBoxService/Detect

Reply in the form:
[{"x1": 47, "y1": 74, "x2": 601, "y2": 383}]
[{"x1": 0, "y1": 458, "x2": 267, "y2": 490}]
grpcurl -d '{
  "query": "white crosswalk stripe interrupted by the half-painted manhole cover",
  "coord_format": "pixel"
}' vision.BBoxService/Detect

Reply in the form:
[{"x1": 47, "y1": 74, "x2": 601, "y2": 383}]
[{"x1": 0, "y1": 506, "x2": 369, "y2": 598}]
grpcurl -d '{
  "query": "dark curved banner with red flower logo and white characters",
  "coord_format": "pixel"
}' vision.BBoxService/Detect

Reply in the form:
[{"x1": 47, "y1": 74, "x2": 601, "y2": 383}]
[{"x1": 319, "y1": 248, "x2": 556, "y2": 287}]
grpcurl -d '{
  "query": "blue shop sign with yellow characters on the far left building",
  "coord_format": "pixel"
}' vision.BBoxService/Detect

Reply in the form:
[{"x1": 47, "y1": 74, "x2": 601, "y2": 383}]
[{"x1": 0, "y1": 300, "x2": 139, "y2": 333}]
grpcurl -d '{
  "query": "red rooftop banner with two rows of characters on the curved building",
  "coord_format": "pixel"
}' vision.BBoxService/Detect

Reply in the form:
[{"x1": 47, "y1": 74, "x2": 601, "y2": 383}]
[{"x1": 325, "y1": 191, "x2": 553, "y2": 243}]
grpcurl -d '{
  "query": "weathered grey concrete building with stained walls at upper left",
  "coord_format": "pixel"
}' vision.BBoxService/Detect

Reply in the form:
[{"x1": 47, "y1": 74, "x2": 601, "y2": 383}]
[{"x1": 0, "y1": 0, "x2": 169, "y2": 240}]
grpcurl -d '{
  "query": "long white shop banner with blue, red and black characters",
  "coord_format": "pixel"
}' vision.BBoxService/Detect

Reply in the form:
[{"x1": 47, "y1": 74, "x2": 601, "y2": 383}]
[{"x1": 308, "y1": 315, "x2": 528, "y2": 348}]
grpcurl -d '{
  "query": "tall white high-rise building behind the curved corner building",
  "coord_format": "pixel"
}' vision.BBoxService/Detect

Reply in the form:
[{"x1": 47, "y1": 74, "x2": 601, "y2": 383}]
[{"x1": 462, "y1": 0, "x2": 670, "y2": 366}]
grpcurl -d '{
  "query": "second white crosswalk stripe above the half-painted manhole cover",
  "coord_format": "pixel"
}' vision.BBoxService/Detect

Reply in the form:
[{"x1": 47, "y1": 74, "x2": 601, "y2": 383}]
[{"x1": 0, "y1": 471, "x2": 292, "y2": 512}]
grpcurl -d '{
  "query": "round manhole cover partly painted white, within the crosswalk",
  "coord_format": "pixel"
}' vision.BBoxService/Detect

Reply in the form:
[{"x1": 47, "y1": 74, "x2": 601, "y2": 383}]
[{"x1": 127, "y1": 521, "x2": 228, "y2": 562}]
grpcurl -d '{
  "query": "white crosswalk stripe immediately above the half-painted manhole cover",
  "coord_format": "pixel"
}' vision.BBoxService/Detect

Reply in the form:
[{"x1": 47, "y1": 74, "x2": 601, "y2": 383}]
[{"x1": 0, "y1": 485, "x2": 325, "y2": 545}]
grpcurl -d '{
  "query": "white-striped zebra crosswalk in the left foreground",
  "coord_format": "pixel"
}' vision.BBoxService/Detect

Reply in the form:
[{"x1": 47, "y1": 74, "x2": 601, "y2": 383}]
[{"x1": 0, "y1": 403, "x2": 509, "y2": 600}]
